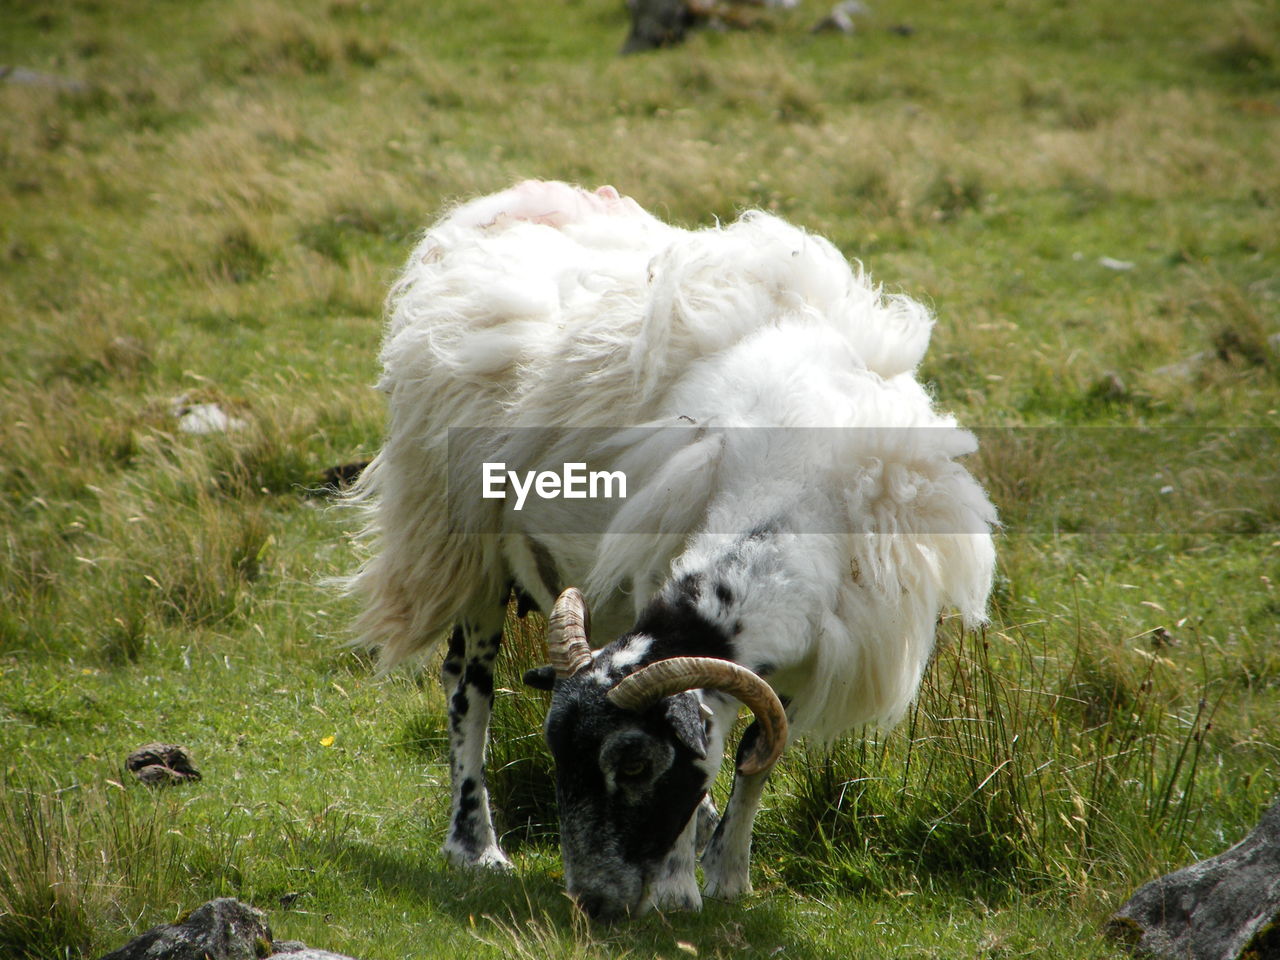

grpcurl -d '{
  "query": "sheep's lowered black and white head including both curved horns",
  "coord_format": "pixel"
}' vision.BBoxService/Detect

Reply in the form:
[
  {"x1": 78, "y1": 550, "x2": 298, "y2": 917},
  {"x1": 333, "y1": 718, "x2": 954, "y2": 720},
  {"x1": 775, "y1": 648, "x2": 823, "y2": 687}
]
[{"x1": 526, "y1": 588, "x2": 786, "y2": 920}]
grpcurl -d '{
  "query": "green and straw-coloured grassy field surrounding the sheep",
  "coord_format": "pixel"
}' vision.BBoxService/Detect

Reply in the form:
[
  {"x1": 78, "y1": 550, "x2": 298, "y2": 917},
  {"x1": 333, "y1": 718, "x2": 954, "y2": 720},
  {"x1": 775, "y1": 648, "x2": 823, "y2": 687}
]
[{"x1": 0, "y1": 0, "x2": 1280, "y2": 960}]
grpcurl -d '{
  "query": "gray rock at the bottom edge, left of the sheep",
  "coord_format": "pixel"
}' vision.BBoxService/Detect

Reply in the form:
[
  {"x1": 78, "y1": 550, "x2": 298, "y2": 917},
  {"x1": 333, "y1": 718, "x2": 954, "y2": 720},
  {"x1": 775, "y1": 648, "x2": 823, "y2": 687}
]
[{"x1": 101, "y1": 897, "x2": 271, "y2": 960}]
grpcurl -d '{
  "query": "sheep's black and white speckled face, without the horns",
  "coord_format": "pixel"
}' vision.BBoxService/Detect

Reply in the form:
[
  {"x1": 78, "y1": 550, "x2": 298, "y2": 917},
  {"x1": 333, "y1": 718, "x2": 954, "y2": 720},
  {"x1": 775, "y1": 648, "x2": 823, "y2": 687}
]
[{"x1": 545, "y1": 671, "x2": 713, "y2": 920}]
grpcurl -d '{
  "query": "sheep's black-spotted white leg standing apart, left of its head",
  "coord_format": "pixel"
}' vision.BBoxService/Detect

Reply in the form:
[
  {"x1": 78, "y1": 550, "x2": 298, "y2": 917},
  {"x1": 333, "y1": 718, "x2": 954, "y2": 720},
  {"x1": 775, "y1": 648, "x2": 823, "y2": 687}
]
[{"x1": 440, "y1": 608, "x2": 511, "y2": 870}]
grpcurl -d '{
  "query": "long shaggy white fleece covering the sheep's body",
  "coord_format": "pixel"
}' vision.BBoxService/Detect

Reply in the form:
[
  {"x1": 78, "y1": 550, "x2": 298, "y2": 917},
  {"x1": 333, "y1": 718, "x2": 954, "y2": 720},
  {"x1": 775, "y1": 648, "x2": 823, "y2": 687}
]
[{"x1": 349, "y1": 182, "x2": 996, "y2": 739}]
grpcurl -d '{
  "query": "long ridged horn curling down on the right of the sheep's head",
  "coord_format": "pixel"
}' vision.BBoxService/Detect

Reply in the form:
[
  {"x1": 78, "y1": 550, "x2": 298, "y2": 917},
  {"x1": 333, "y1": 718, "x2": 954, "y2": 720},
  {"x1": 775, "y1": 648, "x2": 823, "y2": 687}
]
[{"x1": 608, "y1": 657, "x2": 787, "y2": 777}]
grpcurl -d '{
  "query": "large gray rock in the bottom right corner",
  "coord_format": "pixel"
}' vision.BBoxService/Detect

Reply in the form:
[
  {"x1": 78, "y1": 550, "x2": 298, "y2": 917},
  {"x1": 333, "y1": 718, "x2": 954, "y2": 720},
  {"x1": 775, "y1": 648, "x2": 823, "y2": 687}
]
[{"x1": 1107, "y1": 800, "x2": 1280, "y2": 960}]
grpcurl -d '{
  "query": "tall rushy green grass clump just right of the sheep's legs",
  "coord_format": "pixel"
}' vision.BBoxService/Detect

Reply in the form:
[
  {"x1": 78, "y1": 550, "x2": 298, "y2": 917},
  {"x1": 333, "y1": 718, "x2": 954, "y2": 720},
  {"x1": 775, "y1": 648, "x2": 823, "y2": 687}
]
[{"x1": 760, "y1": 619, "x2": 1213, "y2": 892}]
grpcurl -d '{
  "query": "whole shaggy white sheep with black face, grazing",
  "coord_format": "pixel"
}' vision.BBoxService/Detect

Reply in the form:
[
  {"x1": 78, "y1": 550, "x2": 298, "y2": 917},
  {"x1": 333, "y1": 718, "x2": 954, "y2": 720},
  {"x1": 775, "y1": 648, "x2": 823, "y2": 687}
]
[{"x1": 349, "y1": 182, "x2": 996, "y2": 918}]
